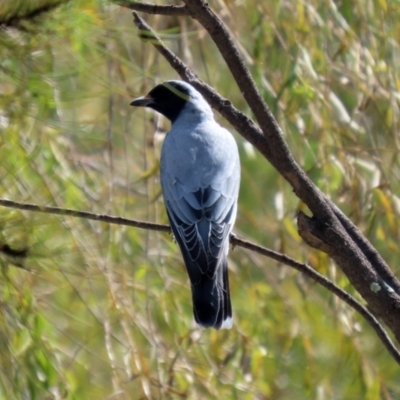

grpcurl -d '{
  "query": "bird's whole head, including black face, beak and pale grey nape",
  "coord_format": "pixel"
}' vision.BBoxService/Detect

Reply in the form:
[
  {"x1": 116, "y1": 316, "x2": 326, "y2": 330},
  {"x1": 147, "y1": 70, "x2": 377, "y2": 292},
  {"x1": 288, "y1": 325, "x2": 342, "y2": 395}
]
[{"x1": 130, "y1": 80, "x2": 212, "y2": 123}]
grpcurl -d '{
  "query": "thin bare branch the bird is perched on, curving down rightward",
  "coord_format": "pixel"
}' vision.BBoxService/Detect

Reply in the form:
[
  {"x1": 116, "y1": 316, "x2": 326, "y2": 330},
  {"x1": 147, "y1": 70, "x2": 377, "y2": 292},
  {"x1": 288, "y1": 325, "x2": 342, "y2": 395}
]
[{"x1": 0, "y1": 199, "x2": 400, "y2": 365}]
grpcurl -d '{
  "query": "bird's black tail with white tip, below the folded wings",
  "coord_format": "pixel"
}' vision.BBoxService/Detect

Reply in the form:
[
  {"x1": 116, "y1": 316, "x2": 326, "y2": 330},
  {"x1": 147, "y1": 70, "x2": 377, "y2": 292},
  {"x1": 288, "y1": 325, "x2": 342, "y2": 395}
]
[{"x1": 192, "y1": 259, "x2": 232, "y2": 329}]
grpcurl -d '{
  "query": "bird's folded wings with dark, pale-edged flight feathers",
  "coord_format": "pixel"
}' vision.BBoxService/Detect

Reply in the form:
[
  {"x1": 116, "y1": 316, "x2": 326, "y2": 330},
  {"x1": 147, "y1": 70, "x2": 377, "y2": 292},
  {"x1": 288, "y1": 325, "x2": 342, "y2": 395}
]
[{"x1": 163, "y1": 168, "x2": 239, "y2": 284}]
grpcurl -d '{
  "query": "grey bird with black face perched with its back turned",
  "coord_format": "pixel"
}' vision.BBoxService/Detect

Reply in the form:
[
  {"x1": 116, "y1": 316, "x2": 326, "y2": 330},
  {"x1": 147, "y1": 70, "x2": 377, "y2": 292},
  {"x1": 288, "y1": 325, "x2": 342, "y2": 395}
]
[{"x1": 130, "y1": 80, "x2": 240, "y2": 330}]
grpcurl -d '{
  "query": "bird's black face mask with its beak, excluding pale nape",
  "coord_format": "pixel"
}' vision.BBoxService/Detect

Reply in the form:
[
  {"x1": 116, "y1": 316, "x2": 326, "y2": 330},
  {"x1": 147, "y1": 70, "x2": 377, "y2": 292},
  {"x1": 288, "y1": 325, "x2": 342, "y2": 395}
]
[{"x1": 131, "y1": 82, "x2": 189, "y2": 123}]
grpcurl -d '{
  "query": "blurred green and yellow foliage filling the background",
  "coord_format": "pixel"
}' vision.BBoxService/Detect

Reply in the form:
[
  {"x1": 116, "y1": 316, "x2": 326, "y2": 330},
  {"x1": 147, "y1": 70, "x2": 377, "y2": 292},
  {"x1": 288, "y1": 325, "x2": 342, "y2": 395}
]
[{"x1": 0, "y1": 0, "x2": 400, "y2": 400}]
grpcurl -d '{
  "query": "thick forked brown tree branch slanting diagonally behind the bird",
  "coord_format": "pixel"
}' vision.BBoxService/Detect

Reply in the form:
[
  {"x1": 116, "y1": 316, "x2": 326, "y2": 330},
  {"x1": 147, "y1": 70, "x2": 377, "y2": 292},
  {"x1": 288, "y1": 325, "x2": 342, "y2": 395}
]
[{"x1": 134, "y1": 0, "x2": 400, "y2": 341}]
